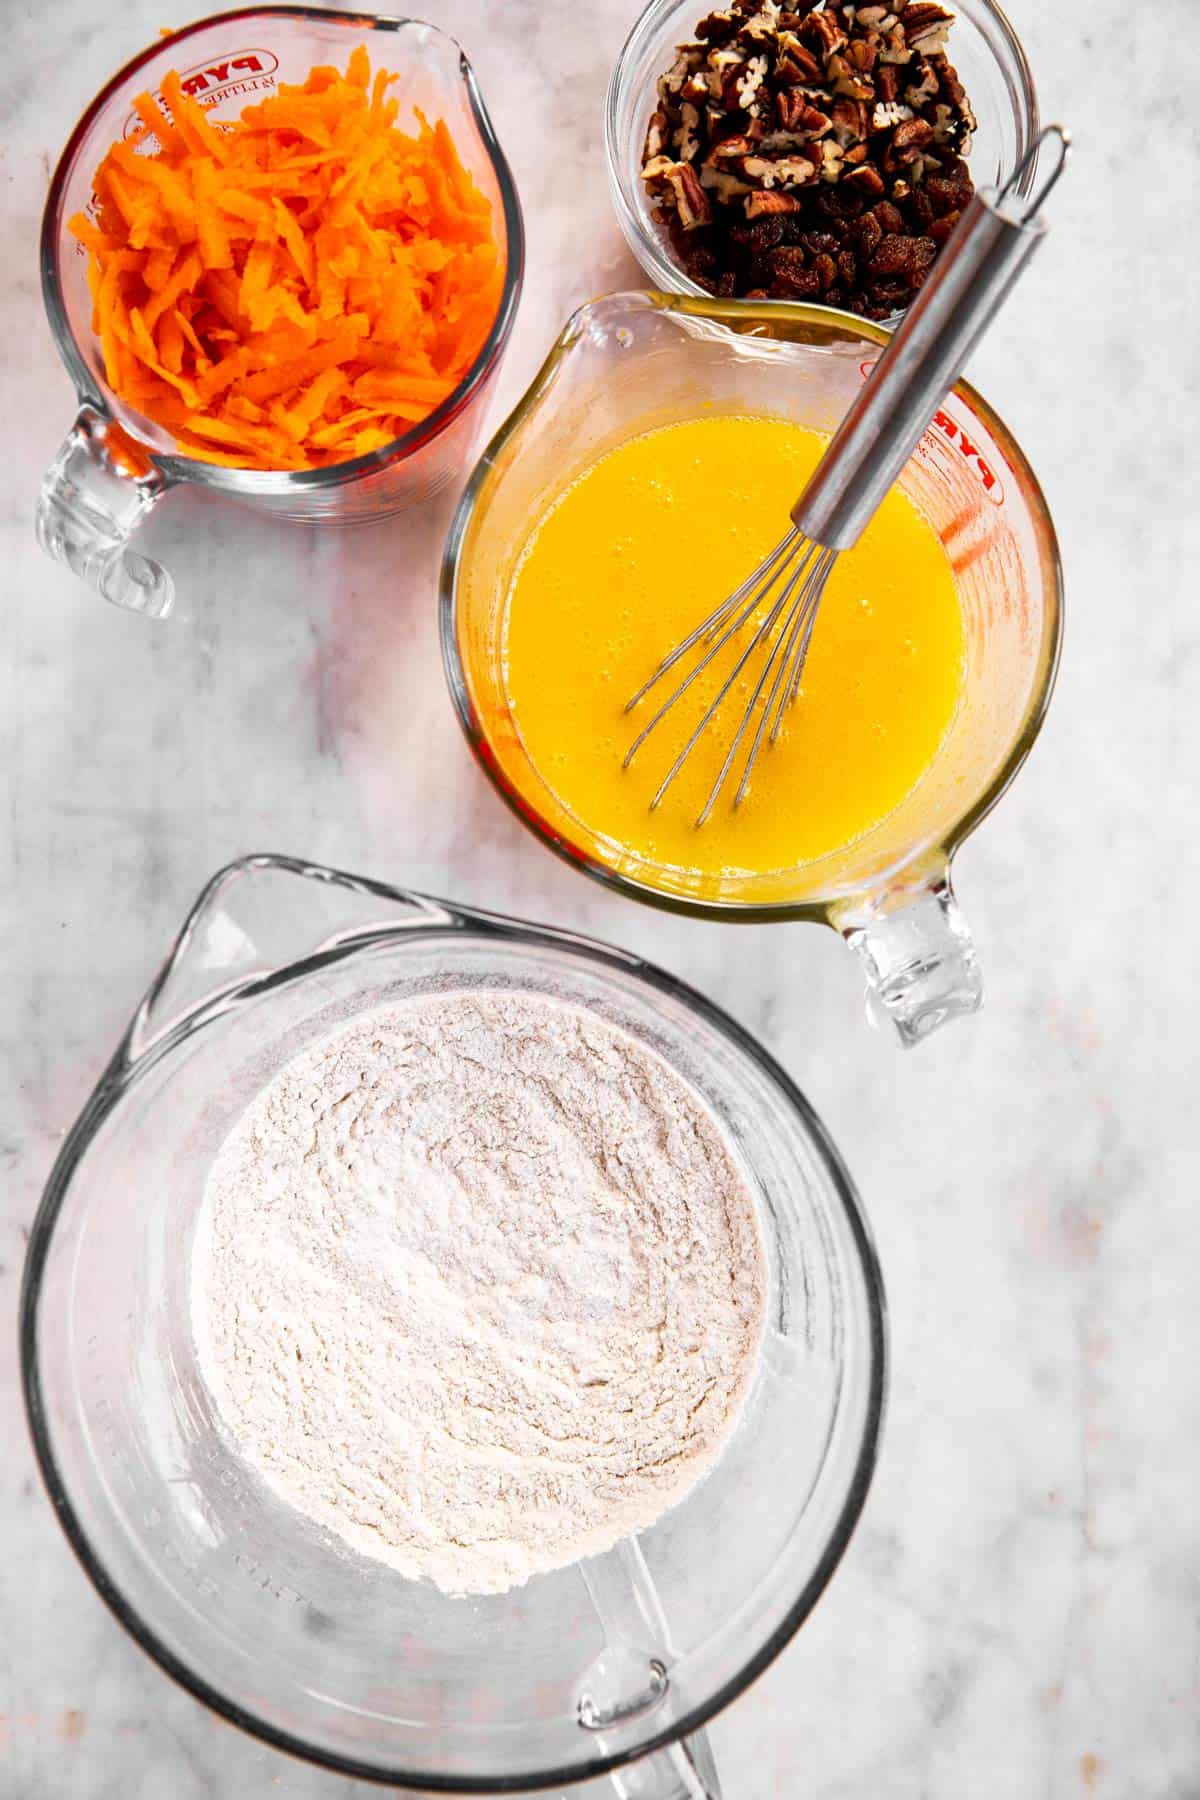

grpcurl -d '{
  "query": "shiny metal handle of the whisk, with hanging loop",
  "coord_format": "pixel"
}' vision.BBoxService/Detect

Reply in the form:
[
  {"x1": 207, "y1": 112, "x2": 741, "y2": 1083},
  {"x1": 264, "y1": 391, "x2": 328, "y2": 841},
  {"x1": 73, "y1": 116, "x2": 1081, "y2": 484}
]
[{"x1": 792, "y1": 126, "x2": 1069, "y2": 551}]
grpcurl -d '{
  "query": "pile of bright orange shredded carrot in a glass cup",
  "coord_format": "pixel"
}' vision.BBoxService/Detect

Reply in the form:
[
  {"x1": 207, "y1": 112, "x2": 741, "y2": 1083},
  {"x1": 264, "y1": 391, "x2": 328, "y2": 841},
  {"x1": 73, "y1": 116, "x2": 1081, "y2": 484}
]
[{"x1": 70, "y1": 45, "x2": 504, "y2": 470}]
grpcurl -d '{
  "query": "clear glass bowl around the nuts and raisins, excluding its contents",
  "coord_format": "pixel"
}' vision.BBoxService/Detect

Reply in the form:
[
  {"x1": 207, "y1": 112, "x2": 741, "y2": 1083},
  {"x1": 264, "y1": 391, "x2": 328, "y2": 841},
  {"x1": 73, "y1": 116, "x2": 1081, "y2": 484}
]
[{"x1": 604, "y1": 0, "x2": 1038, "y2": 304}]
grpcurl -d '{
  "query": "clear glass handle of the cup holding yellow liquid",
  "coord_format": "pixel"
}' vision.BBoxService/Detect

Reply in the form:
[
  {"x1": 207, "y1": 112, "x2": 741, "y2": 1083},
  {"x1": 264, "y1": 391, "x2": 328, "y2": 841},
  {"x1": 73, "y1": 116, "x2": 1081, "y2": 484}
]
[{"x1": 831, "y1": 862, "x2": 984, "y2": 1049}]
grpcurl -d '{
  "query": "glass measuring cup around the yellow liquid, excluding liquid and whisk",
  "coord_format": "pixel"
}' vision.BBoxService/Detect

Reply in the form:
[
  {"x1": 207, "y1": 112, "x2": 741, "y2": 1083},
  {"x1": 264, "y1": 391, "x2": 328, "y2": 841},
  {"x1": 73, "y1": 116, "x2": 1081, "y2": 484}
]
[{"x1": 441, "y1": 293, "x2": 1061, "y2": 1044}]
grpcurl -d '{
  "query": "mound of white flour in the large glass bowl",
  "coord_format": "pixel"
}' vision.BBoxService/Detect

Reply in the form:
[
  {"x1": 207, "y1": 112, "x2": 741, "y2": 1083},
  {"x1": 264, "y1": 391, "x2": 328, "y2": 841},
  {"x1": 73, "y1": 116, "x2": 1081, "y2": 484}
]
[{"x1": 193, "y1": 990, "x2": 765, "y2": 1593}]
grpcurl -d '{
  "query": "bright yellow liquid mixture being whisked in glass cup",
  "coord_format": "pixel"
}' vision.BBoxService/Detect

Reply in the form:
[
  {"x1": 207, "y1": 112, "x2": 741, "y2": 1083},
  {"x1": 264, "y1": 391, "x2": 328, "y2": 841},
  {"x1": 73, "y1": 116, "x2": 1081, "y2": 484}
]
[{"x1": 504, "y1": 416, "x2": 963, "y2": 877}]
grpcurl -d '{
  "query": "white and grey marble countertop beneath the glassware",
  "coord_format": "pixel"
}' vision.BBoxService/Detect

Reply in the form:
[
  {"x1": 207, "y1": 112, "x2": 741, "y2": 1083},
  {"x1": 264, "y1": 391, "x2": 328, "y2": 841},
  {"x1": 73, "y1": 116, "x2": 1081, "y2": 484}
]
[{"x1": 0, "y1": 0, "x2": 1200, "y2": 1800}]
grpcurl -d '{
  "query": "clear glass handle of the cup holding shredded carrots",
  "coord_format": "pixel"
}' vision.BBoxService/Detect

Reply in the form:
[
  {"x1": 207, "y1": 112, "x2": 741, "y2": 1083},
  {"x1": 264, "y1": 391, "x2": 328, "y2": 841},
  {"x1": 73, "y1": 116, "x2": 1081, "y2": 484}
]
[{"x1": 36, "y1": 407, "x2": 175, "y2": 619}]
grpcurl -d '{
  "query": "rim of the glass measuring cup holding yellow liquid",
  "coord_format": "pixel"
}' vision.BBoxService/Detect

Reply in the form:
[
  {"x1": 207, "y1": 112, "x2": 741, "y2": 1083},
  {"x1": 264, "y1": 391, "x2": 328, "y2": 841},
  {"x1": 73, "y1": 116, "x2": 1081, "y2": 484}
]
[{"x1": 437, "y1": 288, "x2": 1065, "y2": 925}]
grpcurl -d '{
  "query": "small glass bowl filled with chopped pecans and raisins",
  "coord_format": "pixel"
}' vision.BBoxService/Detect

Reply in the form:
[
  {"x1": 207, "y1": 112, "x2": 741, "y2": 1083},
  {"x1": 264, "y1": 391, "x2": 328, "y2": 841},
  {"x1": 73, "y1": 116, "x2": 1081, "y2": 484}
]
[{"x1": 604, "y1": 0, "x2": 1038, "y2": 324}]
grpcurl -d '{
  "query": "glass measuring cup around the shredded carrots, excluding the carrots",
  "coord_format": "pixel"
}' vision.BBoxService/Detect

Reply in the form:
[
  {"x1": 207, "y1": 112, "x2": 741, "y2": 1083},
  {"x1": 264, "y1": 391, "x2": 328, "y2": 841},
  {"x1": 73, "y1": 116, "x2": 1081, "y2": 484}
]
[{"x1": 36, "y1": 5, "x2": 524, "y2": 617}]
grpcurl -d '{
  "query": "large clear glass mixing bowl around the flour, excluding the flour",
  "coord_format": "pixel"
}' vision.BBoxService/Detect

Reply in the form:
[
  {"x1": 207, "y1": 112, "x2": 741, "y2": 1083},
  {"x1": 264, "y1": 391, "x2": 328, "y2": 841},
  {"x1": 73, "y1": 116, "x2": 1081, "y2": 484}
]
[{"x1": 22, "y1": 857, "x2": 885, "y2": 1800}]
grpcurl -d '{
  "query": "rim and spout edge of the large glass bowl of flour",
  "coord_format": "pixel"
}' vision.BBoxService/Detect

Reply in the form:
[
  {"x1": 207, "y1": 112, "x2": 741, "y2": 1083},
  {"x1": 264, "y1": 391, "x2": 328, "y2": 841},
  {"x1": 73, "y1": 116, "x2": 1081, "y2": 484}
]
[{"x1": 20, "y1": 853, "x2": 889, "y2": 1795}]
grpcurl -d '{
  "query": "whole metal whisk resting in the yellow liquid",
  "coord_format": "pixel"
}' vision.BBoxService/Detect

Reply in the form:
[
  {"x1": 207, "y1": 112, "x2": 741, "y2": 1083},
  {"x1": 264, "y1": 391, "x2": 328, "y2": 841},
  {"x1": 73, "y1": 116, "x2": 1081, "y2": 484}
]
[{"x1": 624, "y1": 124, "x2": 1070, "y2": 824}]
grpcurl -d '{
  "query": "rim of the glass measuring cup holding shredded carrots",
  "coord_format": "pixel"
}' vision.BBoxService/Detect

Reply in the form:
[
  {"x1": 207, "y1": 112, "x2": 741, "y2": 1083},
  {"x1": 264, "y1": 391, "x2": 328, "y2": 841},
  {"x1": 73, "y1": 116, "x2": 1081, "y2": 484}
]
[{"x1": 38, "y1": 5, "x2": 525, "y2": 499}]
